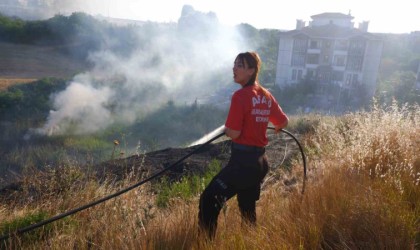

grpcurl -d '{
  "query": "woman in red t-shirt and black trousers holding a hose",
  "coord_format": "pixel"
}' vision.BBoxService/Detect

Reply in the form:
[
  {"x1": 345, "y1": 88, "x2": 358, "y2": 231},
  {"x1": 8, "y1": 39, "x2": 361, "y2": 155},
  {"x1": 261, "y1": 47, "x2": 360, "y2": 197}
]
[{"x1": 198, "y1": 52, "x2": 288, "y2": 238}]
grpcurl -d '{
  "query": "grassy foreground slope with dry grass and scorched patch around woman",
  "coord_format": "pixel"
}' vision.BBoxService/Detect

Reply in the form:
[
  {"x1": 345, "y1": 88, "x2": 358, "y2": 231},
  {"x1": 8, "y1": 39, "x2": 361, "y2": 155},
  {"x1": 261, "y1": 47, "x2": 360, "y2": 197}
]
[{"x1": 0, "y1": 105, "x2": 420, "y2": 249}]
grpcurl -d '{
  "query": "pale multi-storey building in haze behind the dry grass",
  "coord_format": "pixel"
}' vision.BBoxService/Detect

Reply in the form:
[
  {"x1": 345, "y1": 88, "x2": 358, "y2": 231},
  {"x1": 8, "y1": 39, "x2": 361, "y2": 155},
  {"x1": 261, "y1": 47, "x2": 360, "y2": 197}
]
[{"x1": 276, "y1": 13, "x2": 383, "y2": 99}]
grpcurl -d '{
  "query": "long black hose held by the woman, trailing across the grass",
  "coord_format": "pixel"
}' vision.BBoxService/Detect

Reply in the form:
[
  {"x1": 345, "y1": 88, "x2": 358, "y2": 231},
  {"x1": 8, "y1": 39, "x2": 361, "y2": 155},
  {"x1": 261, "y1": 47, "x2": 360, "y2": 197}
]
[{"x1": 0, "y1": 127, "x2": 306, "y2": 241}]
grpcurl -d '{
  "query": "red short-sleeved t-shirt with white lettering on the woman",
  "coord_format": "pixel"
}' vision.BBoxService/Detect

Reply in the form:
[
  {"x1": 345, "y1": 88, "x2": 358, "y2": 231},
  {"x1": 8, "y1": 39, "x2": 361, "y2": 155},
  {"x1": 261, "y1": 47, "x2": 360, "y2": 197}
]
[{"x1": 225, "y1": 84, "x2": 287, "y2": 147}]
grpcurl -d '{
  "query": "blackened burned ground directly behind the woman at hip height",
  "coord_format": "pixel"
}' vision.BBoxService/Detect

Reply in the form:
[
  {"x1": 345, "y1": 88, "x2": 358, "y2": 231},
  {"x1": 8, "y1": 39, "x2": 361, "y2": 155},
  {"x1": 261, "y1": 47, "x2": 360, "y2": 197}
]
[{"x1": 95, "y1": 134, "x2": 299, "y2": 184}]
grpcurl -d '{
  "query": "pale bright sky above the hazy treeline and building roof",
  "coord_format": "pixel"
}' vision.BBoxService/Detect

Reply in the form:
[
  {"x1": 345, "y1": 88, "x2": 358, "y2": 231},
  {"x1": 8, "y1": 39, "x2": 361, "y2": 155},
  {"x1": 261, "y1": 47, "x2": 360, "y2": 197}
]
[{"x1": 74, "y1": 0, "x2": 420, "y2": 33}]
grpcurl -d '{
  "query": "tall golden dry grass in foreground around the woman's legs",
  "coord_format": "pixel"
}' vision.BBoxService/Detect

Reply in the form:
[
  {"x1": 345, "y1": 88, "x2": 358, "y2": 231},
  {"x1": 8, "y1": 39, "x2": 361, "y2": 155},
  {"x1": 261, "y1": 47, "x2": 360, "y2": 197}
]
[{"x1": 0, "y1": 104, "x2": 420, "y2": 249}]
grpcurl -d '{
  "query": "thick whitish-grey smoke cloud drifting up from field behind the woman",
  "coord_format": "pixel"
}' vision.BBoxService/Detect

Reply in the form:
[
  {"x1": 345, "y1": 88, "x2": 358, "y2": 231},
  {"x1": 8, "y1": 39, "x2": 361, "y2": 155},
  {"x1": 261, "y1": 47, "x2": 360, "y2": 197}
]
[{"x1": 37, "y1": 6, "x2": 249, "y2": 135}]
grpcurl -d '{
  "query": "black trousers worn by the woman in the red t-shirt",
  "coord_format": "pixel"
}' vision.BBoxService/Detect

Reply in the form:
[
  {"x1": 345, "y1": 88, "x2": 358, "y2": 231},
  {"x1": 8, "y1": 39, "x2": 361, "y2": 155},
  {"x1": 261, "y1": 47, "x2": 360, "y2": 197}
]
[{"x1": 198, "y1": 148, "x2": 268, "y2": 238}]
